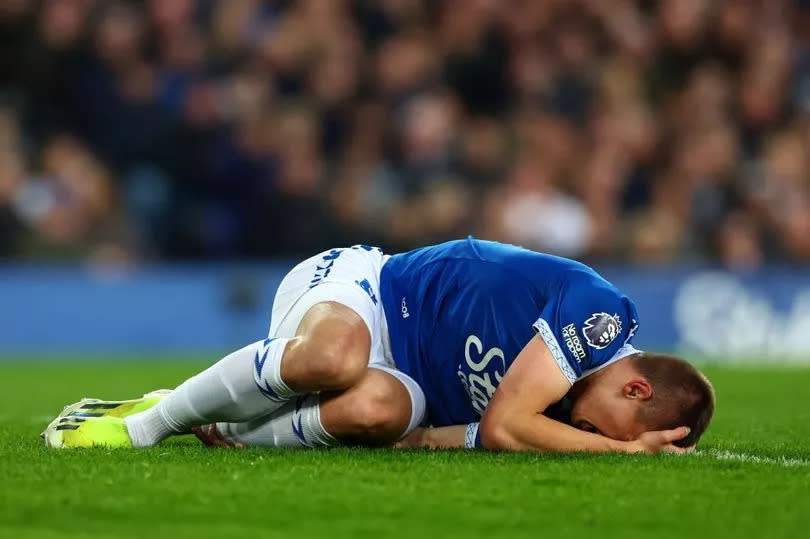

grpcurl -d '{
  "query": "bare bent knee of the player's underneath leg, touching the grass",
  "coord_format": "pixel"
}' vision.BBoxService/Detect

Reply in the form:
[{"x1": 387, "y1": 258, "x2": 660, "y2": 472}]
[{"x1": 320, "y1": 368, "x2": 416, "y2": 445}]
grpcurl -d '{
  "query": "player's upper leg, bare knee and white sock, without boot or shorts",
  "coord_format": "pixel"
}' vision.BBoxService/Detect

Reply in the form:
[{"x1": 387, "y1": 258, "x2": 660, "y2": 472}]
[{"x1": 125, "y1": 302, "x2": 370, "y2": 447}]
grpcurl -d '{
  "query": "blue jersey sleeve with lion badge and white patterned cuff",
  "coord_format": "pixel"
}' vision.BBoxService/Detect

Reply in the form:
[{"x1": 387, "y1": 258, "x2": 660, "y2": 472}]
[{"x1": 534, "y1": 281, "x2": 638, "y2": 384}]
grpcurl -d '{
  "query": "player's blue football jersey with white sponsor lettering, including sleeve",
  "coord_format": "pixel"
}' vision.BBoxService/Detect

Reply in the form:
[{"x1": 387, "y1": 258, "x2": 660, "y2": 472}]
[{"x1": 380, "y1": 238, "x2": 638, "y2": 426}]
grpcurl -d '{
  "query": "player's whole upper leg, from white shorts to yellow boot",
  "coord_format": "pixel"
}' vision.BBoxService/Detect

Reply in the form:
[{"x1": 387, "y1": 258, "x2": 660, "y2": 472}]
[{"x1": 46, "y1": 248, "x2": 383, "y2": 447}]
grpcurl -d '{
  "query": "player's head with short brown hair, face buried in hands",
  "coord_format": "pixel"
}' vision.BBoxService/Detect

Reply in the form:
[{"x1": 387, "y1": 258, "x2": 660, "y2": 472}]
[{"x1": 571, "y1": 352, "x2": 714, "y2": 447}]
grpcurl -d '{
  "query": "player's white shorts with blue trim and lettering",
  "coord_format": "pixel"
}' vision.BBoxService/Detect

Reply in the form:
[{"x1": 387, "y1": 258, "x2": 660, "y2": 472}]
[{"x1": 268, "y1": 245, "x2": 425, "y2": 434}]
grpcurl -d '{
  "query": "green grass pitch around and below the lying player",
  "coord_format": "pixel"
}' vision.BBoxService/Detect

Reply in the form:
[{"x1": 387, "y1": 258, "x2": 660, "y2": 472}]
[{"x1": 0, "y1": 361, "x2": 810, "y2": 539}]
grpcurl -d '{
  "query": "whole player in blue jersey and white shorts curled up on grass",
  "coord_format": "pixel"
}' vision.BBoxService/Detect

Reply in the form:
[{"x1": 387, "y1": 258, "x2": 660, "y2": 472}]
[{"x1": 43, "y1": 238, "x2": 714, "y2": 453}]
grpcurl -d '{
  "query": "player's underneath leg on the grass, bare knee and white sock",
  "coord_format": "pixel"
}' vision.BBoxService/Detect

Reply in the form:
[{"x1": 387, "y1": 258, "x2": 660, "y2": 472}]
[{"x1": 204, "y1": 367, "x2": 425, "y2": 447}]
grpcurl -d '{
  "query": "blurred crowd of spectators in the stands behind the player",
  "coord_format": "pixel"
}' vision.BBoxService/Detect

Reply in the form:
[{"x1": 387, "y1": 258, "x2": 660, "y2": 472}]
[{"x1": 0, "y1": 0, "x2": 810, "y2": 268}]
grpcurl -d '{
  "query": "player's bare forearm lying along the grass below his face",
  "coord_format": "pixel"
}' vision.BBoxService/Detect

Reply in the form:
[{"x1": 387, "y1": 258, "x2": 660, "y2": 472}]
[{"x1": 481, "y1": 414, "x2": 631, "y2": 453}]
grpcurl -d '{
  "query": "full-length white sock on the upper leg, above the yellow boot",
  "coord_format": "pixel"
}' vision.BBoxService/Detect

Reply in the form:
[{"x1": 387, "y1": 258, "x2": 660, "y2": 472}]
[{"x1": 125, "y1": 339, "x2": 295, "y2": 447}]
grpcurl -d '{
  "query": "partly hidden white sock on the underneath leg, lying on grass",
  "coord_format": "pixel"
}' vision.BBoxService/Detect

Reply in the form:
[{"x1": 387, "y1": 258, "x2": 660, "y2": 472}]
[{"x1": 217, "y1": 393, "x2": 340, "y2": 447}]
